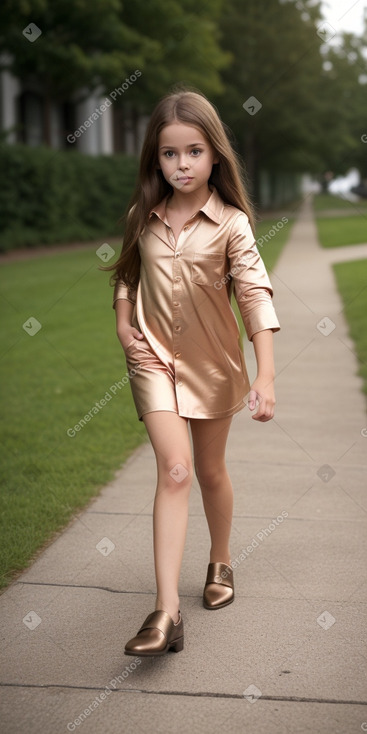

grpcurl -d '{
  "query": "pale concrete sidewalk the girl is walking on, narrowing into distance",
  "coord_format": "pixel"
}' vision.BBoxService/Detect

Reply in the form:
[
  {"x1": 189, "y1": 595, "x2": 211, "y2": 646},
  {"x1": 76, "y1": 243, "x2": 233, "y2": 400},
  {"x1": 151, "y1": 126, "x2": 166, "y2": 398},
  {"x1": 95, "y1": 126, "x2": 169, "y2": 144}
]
[{"x1": 0, "y1": 199, "x2": 367, "y2": 734}]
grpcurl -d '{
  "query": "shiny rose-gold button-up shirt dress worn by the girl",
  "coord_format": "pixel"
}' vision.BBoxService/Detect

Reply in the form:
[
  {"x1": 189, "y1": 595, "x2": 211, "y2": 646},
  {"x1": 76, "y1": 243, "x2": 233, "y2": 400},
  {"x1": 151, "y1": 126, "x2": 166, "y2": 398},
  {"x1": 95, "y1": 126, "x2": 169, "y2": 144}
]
[{"x1": 113, "y1": 185, "x2": 280, "y2": 420}]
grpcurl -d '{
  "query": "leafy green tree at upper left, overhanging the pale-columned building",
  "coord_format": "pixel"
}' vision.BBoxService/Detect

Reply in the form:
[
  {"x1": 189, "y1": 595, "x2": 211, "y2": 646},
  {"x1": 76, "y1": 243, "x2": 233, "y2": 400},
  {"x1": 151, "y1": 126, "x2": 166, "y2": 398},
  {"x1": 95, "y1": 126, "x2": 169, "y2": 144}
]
[{"x1": 0, "y1": 0, "x2": 230, "y2": 147}]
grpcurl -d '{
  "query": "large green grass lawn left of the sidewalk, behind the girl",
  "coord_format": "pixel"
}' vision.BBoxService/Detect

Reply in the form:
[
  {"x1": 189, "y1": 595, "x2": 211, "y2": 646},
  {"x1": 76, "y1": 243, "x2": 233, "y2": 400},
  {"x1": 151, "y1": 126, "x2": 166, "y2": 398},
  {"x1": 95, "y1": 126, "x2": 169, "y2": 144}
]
[{"x1": 0, "y1": 220, "x2": 290, "y2": 587}]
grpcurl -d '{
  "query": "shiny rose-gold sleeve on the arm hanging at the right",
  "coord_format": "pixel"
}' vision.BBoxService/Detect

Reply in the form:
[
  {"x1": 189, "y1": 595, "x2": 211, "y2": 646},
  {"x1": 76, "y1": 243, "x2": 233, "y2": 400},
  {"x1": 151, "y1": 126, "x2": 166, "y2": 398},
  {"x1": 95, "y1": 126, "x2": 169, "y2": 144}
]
[{"x1": 227, "y1": 213, "x2": 281, "y2": 341}]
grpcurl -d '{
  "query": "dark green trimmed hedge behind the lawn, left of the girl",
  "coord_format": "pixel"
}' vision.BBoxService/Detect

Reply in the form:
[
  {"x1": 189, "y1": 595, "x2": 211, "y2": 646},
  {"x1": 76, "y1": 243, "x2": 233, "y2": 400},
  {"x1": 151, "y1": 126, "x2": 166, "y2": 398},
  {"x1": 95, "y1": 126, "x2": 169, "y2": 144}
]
[{"x1": 0, "y1": 144, "x2": 138, "y2": 252}]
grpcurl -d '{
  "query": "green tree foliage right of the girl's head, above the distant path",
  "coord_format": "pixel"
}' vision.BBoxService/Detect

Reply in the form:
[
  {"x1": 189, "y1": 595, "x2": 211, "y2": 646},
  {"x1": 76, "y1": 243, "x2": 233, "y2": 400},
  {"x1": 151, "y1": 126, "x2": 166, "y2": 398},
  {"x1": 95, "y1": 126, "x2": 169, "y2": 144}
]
[{"x1": 210, "y1": 0, "x2": 367, "y2": 190}]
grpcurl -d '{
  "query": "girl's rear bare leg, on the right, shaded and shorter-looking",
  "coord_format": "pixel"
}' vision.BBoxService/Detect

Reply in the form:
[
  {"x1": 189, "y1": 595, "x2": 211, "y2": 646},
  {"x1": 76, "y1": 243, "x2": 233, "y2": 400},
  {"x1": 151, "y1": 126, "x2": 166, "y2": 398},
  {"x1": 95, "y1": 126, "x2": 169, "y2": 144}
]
[{"x1": 190, "y1": 416, "x2": 233, "y2": 564}]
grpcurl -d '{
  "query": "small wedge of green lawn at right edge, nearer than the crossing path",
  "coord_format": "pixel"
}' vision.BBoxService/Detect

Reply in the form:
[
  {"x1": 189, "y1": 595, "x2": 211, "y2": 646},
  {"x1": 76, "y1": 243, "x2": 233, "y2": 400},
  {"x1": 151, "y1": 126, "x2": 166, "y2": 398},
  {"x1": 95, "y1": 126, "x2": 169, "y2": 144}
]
[{"x1": 333, "y1": 260, "x2": 367, "y2": 395}]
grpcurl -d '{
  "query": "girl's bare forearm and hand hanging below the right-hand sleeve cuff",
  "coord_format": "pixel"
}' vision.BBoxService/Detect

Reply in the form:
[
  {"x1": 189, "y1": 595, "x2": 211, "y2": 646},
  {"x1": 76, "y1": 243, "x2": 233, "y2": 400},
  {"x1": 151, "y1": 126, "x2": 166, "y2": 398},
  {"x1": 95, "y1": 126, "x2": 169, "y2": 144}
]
[{"x1": 248, "y1": 329, "x2": 275, "y2": 422}]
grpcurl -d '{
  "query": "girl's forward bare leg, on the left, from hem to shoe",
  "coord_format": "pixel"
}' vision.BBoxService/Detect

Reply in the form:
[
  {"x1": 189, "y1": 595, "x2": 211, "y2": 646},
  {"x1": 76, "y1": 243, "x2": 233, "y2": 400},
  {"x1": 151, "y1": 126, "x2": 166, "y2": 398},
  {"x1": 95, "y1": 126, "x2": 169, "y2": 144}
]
[{"x1": 142, "y1": 410, "x2": 193, "y2": 622}]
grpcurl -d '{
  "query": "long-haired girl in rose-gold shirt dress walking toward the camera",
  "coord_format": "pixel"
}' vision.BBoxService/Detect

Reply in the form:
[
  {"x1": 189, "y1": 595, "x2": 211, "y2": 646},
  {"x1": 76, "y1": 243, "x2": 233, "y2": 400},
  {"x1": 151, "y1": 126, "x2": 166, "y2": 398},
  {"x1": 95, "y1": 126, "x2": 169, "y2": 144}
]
[{"x1": 107, "y1": 90, "x2": 280, "y2": 656}]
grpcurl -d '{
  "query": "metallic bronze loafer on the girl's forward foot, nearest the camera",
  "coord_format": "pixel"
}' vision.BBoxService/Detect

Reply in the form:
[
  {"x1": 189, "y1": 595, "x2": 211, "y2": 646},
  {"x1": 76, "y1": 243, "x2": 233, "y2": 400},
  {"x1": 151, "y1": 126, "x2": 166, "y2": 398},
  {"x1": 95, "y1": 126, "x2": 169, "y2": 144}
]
[{"x1": 125, "y1": 609, "x2": 183, "y2": 657}]
